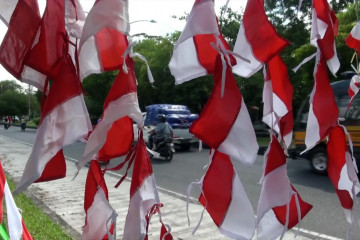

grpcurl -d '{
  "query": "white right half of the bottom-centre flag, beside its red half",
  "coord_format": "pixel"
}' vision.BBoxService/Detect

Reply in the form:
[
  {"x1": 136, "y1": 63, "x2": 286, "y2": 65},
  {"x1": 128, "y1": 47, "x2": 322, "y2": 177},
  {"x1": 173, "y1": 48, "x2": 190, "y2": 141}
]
[{"x1": 219, "y1": 169, "x2": 255, "y2": 239}]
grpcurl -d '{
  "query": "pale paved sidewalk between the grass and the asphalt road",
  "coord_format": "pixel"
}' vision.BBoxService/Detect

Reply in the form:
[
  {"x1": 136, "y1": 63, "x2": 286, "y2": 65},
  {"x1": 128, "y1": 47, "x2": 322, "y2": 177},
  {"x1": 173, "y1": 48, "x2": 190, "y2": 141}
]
[{"x1": 0, "y1": 137, "x2": 335, "y2": 240}]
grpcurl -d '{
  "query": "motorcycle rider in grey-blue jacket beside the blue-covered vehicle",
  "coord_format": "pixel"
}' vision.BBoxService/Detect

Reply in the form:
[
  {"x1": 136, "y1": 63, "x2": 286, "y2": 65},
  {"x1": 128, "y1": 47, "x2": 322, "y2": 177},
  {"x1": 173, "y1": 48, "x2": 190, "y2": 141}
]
[{"x1": 149, "y1": 114, "x2": 172, "y2": 150}]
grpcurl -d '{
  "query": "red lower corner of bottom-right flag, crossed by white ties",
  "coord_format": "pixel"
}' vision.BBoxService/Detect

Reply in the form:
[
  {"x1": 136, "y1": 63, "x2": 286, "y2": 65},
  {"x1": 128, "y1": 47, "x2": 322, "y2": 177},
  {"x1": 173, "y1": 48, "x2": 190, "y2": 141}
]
[{"x1": 273, "y1": 185, "x2": 313, "y2": 229}]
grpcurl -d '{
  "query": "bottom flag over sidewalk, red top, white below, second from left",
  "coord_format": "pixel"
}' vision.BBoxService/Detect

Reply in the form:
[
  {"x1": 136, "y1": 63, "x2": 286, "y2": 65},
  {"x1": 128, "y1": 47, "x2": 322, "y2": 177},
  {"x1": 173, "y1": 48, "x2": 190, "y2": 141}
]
[{"x1": 81, "y1": 160, "x2": 117, "y2": 240}]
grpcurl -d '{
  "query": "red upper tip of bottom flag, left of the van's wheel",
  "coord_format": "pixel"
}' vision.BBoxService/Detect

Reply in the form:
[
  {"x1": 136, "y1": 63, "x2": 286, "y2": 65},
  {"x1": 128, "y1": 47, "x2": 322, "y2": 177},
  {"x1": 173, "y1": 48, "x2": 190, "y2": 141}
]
[{"x1": 264, "y1": 135, "x2": 286, "y2": 176}]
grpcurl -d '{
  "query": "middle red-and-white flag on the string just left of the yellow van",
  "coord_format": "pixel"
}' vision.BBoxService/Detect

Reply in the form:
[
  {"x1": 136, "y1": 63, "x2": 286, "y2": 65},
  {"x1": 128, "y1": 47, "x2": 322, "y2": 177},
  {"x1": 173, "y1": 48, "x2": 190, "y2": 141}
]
[{"x1": 263, "y1": 55, "x2": 294, "y2": 147}]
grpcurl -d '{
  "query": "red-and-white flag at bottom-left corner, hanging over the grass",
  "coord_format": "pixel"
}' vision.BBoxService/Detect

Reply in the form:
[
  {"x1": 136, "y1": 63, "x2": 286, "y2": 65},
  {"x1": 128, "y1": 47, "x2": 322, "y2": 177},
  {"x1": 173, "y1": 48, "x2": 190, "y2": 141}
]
[{"x1": 0, "y1": 161, "x2": 33, "y2": 240}]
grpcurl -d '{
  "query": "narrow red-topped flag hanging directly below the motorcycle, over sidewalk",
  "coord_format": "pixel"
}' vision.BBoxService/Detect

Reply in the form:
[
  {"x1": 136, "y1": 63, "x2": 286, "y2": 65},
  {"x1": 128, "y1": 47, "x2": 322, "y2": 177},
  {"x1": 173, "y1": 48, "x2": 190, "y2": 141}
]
[{"x1": 123, "y1": 133, "x2": 160, "y2": 240}]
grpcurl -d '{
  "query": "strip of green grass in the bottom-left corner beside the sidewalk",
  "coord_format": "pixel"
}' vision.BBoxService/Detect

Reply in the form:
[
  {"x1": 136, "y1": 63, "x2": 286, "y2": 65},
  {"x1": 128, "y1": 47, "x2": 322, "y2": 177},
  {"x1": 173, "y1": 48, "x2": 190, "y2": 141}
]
[{"x1": 6, "y1": 175, "x2": 73, "y2": 240}]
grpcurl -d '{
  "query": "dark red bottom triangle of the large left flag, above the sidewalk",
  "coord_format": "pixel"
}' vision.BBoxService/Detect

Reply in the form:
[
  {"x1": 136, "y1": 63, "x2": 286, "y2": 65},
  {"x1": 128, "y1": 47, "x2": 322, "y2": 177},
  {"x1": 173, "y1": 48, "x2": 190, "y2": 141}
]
[{"x1": 35, "y1": 149, "x2": 66, "y2": 182}]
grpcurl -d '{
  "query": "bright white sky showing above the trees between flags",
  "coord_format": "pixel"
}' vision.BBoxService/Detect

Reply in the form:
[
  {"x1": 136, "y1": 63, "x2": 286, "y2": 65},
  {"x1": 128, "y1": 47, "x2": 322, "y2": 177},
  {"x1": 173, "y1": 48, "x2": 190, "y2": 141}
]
[{"x1": 0, "y1": 0, "x2": 247, "y2": 84}]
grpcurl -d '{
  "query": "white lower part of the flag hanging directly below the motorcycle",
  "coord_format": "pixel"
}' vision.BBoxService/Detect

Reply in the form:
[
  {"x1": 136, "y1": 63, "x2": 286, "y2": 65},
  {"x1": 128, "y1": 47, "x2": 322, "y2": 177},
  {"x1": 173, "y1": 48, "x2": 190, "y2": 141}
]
[{"x1": 123, "y1": 174, "x2": 160, "y2": 240}]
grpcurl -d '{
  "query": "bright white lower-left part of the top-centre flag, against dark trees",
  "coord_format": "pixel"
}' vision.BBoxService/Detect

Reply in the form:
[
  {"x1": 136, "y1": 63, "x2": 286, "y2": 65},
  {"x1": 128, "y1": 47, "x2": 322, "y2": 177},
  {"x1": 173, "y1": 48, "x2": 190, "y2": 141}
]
[{"x1": 169, "y1": 38, "x2": 207, "y2": 84}]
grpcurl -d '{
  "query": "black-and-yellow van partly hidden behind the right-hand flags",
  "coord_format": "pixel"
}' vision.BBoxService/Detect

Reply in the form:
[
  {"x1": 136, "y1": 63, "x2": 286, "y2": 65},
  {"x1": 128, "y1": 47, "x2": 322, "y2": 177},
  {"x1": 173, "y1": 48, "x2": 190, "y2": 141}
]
[{"x1": 289, "y1": 77, "x2": 360, "y2": 174}]
